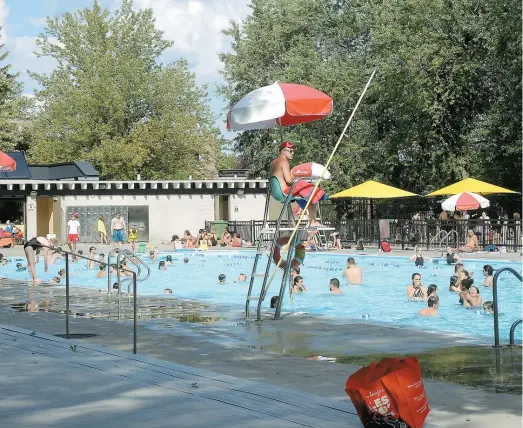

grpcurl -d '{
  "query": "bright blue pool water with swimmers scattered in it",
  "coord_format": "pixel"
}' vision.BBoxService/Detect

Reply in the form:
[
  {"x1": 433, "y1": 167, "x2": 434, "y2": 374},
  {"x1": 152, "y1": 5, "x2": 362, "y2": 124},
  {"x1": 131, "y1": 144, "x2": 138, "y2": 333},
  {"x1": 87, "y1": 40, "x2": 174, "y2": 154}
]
[{"x1": 0, "y1": 251, "x2": 522, "y2": 343}]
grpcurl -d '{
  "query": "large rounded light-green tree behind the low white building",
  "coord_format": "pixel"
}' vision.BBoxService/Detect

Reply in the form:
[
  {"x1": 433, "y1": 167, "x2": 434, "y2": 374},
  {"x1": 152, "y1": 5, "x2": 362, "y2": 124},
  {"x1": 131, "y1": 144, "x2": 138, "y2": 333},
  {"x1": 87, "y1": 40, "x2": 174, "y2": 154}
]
[{"x1": 31, "y1": 0, "x2": 219, "y2": 179}]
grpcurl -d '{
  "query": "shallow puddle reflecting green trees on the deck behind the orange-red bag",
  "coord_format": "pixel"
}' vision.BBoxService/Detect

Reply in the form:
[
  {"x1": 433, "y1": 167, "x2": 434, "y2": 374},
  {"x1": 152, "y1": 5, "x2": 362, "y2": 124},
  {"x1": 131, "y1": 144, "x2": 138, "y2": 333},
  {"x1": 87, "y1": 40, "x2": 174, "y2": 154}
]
[{"x1": 336, "y1": 346, "x2": 522, "y2": 395}]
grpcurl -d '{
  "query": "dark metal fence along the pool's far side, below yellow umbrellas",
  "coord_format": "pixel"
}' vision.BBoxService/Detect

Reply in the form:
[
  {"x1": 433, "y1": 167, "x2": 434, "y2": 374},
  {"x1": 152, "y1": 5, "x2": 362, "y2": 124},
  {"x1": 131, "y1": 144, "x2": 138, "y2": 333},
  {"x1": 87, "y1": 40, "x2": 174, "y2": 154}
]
[{"x1": 205, "y1": 219, "x2": 522, "y2": 251}]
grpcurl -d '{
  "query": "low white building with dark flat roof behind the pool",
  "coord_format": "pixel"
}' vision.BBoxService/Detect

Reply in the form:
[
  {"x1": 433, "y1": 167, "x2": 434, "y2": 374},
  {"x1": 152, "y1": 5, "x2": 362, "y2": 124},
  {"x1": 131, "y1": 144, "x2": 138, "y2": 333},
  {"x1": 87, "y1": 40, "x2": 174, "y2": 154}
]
[{"x1": 0, "y1": 153, "x2": 279, "y2": 242}]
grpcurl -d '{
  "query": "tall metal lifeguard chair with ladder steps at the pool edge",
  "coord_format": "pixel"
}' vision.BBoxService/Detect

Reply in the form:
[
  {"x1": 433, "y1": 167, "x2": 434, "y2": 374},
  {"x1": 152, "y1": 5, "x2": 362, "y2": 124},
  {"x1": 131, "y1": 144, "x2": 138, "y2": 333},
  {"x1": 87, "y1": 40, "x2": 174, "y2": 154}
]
[{"x1": 245, "y1": 176, "x2": 334, "y2": 321}]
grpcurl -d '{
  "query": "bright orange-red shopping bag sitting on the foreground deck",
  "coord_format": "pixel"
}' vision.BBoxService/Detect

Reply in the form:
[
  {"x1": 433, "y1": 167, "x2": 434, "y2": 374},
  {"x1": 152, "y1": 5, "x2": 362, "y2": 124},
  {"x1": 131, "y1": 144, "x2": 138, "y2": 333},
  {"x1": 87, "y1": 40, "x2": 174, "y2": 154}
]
[{"x1": 345, "y1": 357, "x2": 430, "y2": 428}]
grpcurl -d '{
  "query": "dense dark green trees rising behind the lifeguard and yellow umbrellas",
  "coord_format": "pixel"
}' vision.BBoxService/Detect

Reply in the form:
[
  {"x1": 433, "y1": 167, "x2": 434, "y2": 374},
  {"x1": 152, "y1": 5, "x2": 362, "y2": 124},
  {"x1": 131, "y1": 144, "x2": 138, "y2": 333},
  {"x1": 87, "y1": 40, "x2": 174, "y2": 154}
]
[{"x1": 221, "y1": 0, "x2": 521, "y2": 194}]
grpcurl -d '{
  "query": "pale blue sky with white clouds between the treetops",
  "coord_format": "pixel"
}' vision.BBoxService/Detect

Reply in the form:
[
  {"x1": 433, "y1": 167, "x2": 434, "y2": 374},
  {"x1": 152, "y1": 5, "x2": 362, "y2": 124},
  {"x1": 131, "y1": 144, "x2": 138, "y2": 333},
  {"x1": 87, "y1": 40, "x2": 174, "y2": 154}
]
[{"x1": 0, "y1": 0, "x2": 250, "y2": 138}]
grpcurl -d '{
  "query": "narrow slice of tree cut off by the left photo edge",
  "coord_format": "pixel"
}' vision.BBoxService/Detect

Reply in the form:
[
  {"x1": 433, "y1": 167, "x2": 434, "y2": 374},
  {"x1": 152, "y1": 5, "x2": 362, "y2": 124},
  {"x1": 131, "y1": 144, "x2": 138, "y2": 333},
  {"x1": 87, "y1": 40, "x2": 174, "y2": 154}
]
[{"x1": 0, "y1": 27, "x2": 29, "y2": 150}]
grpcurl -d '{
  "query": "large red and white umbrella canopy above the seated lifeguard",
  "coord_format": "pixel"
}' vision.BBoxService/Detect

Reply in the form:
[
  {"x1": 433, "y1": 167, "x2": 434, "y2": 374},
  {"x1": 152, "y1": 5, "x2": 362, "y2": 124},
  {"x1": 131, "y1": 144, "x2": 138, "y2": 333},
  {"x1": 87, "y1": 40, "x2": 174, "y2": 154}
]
[{"x1": 227, "y1": 83, "x2": 333, "y2": 131}]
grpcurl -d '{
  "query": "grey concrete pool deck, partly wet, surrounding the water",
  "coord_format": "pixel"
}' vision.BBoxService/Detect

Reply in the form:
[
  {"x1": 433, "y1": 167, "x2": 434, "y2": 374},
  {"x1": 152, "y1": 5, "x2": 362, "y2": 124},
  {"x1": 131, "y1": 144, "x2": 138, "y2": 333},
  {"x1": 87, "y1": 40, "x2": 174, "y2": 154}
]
[{"x1": 0, "y1": 245, "x2": 523, "y2": 428}]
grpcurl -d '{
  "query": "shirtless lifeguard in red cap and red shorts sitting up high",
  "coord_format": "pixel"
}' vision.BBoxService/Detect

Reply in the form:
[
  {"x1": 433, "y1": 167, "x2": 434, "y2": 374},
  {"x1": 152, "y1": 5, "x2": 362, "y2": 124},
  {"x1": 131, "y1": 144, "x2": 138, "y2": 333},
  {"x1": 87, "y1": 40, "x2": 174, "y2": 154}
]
[{"x1": 271, "y1": 141, "x2": 327, "y2": 228}]
